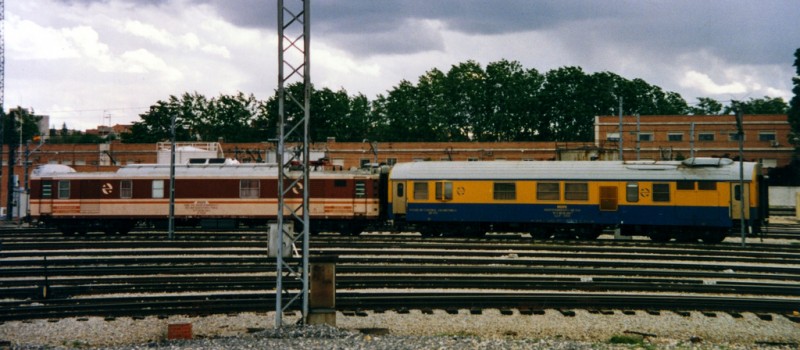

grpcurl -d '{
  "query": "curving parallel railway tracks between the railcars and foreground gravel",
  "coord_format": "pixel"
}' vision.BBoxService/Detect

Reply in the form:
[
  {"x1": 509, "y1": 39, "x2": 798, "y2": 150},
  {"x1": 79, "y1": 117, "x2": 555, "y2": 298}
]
[{"x1": 0, "y1": 228, "x2": 800, "y2": 321}]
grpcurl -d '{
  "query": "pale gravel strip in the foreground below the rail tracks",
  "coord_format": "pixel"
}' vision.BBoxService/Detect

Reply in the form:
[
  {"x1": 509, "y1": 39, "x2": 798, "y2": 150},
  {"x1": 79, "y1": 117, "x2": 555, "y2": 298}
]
[{"x1": 0, "y1": 309, "x2": 800, "y2": 349}]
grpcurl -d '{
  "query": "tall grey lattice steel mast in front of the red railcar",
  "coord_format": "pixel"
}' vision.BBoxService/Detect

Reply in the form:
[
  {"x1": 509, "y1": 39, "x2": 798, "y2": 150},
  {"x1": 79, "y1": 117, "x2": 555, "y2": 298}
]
[{"x1": 275, "y1": 0, "x2": 311, "y2": 328}]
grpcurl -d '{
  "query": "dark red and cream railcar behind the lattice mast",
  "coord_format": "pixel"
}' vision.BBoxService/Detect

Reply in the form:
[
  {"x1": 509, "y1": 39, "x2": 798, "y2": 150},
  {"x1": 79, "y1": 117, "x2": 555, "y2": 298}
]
[{"x1": 30, "y1": 163, "x2": 385, "y2": 234}]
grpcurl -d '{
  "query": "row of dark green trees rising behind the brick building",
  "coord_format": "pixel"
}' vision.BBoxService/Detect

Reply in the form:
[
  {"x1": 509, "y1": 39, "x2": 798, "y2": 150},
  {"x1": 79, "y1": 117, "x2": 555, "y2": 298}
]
[{"x1": 117, "y1": 60, "x2": 789, "y2": 143}]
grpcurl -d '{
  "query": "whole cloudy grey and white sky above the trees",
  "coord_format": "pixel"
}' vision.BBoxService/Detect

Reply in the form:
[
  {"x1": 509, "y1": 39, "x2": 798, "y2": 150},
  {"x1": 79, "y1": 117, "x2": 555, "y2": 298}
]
[{"x1": 5, "y1": 0, "x2": 800, "y2": 129}]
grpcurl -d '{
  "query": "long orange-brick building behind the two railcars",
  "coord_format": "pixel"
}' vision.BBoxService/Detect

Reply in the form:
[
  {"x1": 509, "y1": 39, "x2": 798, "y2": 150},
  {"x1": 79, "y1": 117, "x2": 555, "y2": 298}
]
[{"x1": 0, "y1": 115, "x2": 794, "y2": 219}]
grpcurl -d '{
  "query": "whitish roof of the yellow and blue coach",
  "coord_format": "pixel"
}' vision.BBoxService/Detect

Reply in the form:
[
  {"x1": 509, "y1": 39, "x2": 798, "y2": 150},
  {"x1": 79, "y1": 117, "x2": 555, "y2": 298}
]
[{"x1": 389, "y1": 158, "x2": 756, "y2": 181}]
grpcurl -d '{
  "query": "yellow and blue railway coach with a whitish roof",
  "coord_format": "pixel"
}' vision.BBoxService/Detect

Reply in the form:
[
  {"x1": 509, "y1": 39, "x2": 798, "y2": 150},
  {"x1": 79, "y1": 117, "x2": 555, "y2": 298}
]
[{"x1": 388, "y1": 158, "x2": 768, "y2": 243}]
